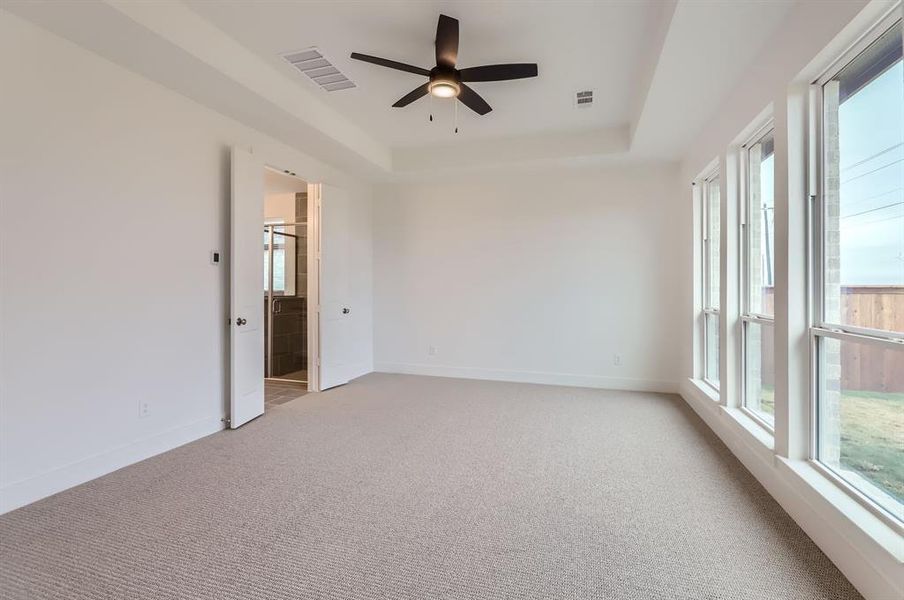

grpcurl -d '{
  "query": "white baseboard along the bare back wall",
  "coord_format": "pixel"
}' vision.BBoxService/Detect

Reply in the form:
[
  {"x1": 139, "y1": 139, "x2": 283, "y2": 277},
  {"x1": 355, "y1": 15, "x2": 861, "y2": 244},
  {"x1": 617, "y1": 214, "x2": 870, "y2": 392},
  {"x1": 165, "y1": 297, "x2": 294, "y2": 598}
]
[{"x1": 374, "y1": 362, "x2": 679, "y2": 394}]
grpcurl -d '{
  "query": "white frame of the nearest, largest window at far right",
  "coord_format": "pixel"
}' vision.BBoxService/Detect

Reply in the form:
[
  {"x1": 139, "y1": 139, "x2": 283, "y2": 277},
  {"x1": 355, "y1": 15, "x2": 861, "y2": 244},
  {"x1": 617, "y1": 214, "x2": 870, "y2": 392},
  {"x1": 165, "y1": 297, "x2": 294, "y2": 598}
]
[{"x1": 807, "y1": 11, "x2": 904, "y2": 534}]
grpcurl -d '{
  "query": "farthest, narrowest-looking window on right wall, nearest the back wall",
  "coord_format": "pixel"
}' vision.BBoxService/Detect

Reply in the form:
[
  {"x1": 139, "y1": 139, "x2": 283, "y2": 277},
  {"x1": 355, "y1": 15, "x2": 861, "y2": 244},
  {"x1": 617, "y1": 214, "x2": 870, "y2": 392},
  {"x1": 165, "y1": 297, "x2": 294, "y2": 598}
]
[{"x1": 701, "y1": 174, "x2": 721, "y2": 389}]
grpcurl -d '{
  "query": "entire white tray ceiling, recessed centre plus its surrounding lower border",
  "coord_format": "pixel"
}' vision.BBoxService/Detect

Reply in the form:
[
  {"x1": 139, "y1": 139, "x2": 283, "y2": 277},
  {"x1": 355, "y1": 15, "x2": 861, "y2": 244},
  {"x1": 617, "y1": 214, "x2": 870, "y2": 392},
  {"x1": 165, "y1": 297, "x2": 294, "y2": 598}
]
[{"x1": 4, "y1": 0, "x2": 796, "y2": 179}]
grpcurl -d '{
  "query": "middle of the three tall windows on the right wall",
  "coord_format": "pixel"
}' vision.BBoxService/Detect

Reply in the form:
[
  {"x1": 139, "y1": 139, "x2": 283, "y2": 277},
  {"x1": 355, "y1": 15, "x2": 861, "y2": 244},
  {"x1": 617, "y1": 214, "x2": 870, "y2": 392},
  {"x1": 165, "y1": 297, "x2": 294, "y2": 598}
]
[{"x1": 740, "y1": 128, "x2": 775, "y2": 429}]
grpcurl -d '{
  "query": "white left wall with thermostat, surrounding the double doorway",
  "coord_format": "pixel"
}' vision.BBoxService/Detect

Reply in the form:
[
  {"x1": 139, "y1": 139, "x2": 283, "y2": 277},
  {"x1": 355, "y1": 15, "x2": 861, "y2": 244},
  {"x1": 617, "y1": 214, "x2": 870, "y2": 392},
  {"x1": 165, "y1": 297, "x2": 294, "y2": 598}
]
[{"x1": 0, "y1": 11, "x2": 373, "y2": 512}]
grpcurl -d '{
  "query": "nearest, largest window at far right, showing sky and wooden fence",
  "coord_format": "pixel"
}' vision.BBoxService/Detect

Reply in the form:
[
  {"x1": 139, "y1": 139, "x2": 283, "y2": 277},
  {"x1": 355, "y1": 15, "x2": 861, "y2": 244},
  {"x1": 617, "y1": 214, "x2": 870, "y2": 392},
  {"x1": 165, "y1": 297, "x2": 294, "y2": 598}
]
[{"x1": 810, "y1": 21, "x2": 904, "y2": 521}]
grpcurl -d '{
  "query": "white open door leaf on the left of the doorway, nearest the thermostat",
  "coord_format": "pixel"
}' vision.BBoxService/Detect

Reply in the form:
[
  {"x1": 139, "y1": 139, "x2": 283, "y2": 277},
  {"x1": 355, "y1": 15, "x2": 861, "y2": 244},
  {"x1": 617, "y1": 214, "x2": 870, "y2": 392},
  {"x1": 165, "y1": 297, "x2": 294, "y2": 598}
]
[{"x1": 229, "y1": 148, "x2": 264, "y2": 429}]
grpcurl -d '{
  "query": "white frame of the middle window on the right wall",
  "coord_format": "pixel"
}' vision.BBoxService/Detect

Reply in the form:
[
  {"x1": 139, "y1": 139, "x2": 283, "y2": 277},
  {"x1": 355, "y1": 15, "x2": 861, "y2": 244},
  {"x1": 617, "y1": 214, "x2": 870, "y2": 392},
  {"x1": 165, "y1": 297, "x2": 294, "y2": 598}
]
[{"x1": 738, "y1": 122, "x2": 775, "y2": 436}]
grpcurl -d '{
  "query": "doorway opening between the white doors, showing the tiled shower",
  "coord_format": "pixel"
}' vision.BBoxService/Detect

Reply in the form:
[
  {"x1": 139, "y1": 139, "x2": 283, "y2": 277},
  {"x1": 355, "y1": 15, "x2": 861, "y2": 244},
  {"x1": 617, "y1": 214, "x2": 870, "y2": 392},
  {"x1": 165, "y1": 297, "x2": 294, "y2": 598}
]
[{"x1": 262, "y1": 168, "x2": 311, "y2": 409}]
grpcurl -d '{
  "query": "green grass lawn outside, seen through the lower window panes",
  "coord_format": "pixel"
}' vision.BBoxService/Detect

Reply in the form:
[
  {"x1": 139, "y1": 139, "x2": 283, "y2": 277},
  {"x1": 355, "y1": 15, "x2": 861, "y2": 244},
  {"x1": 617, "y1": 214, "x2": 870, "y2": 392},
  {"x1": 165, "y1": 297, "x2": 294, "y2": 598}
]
[{"x1": 760, "y1": 386, "x2": 904, "y2": 502}]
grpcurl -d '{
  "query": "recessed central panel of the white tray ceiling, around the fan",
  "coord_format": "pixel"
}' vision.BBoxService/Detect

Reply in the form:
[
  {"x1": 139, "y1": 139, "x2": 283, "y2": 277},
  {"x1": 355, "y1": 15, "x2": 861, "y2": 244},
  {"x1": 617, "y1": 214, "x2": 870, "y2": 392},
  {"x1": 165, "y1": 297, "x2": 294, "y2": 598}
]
[{"x1": 187, "y1": 0, "x2": 661, "y2": 147}]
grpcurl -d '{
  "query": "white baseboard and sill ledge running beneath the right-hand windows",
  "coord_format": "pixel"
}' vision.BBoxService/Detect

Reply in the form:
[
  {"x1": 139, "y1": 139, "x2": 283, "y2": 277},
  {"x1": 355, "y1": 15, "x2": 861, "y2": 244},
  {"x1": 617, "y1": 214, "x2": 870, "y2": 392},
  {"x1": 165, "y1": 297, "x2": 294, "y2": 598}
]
[{"x1": 680, "y1": 380, "x2": 904, "y2": 600}]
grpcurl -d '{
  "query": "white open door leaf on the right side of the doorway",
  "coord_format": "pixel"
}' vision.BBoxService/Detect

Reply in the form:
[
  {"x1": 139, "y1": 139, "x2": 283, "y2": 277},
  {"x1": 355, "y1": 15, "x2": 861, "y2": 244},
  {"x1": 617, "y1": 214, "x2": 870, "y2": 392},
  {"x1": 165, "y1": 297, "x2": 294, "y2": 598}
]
[{"x1": 317, "y1": 184, "x2": 355, "y2": 390}]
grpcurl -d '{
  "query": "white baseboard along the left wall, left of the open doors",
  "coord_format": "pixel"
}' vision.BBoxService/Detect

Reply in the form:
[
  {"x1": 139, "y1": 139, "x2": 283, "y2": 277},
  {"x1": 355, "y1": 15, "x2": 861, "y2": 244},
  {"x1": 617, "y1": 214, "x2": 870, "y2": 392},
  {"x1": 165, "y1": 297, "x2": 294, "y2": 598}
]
[{"x1": 0, "y1": 417, "x2": 224, "y2": 514}]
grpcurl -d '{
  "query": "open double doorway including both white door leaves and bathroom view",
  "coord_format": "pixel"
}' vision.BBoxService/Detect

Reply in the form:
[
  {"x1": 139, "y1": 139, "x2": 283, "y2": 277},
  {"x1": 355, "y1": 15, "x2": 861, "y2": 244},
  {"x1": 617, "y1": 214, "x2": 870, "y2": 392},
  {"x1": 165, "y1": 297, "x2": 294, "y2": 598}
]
[{"x1": 226, "y1": 146, "x2": 354, "y2": 429}]
